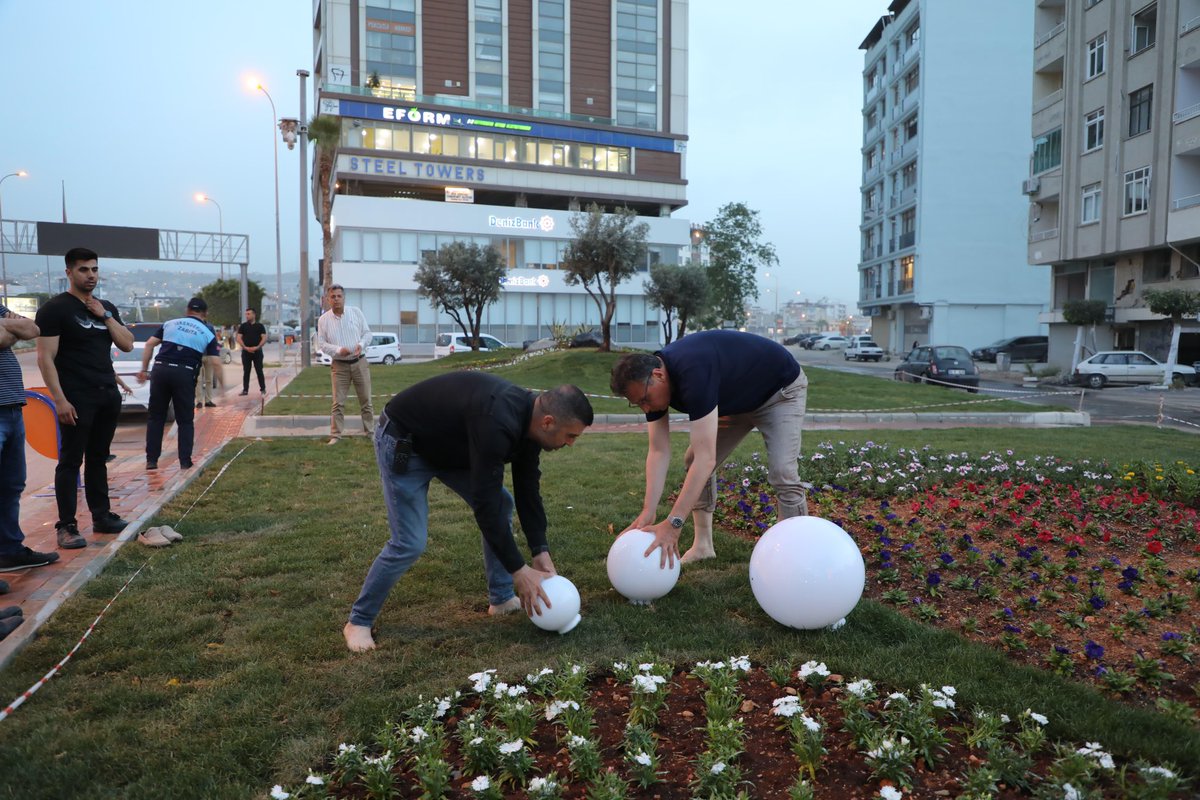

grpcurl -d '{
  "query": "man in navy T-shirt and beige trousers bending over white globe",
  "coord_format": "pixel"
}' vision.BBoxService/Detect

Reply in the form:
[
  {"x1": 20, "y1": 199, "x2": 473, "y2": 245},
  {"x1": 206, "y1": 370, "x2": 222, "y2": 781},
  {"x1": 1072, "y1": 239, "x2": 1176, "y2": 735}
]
[{"x1": 610, "y1": 331, "x2": 809, "y2": 564}]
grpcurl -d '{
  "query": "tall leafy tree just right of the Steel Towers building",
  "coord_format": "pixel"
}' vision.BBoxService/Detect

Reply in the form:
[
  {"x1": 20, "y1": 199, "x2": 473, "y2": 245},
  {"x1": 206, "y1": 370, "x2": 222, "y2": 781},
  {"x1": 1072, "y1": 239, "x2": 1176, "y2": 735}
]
[{"x1": 704, "y1": 203, "x2": 779, "y2": 327}]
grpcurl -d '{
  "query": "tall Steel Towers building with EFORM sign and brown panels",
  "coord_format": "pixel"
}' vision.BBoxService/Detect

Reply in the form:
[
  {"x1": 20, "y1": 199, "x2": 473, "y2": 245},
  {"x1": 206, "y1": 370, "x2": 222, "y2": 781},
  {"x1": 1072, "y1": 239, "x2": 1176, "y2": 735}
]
[{"x1": 313, "y1": 0, "x2": 691, "y2": 353}]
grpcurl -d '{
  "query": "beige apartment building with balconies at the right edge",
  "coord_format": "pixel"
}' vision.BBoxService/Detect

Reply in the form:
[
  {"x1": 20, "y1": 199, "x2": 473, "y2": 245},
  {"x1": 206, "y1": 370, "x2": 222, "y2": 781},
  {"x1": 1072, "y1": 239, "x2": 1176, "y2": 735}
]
[{"x1": 1024, "y1": 0, "x2": 1200, "y2": 366}]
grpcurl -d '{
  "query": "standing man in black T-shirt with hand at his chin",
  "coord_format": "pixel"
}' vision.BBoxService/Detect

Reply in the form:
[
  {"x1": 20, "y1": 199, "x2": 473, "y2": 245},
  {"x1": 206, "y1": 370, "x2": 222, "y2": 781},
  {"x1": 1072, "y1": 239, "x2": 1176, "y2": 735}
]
[{"x1": 35, "y1": 247, "x2": 133, "y2": 549}]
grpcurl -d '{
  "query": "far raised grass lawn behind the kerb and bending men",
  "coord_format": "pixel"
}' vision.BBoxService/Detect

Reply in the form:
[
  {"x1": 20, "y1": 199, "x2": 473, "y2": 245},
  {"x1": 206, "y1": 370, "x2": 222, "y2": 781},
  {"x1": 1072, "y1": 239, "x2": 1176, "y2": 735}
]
[{"x1": 266, "y1": 349, "x2": 1062, "y2": 415}]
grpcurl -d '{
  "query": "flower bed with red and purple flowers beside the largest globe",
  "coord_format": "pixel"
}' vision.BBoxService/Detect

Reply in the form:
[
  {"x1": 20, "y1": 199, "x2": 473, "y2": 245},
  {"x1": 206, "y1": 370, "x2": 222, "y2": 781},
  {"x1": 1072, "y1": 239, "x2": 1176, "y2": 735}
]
[{"x1": 718, "y1": 445, "x2": 1200, "y2": 722}]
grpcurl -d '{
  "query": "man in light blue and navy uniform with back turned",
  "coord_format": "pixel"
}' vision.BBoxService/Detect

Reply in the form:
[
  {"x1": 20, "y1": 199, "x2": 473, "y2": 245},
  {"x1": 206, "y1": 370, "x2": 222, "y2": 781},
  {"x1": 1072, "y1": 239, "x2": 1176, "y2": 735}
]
[{"x1": 138, "y1": 297, "x2": 224, "y2": 469}]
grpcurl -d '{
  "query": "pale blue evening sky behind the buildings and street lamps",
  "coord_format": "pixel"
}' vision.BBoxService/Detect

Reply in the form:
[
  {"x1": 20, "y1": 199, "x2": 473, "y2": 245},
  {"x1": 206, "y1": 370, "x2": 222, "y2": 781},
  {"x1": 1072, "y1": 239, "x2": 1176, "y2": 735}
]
[{"x1": 0, "y1": 0, "x2": 887, "y2": 306}]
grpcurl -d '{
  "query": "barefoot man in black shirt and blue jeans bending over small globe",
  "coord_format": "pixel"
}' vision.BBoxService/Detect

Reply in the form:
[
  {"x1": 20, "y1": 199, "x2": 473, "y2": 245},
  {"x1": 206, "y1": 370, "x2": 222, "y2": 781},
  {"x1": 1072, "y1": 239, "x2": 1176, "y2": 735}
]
[{"x1": 342, "y1": 372, "x2": 593, "y2": 652}]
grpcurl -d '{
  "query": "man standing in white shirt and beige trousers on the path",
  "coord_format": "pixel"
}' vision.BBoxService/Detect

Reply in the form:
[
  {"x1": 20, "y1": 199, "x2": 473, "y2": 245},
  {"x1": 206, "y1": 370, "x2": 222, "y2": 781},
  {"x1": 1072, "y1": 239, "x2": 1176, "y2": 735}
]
[{"x1": 317, "y1": 283, "x2": 374, "y2": 445}]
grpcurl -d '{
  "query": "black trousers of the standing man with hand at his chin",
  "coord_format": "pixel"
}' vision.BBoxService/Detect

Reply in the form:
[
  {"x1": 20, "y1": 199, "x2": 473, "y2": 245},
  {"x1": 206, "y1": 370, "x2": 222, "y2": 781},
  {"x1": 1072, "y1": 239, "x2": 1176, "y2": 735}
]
[{"x1": 54, "y1": 383, "x2": 121, "y2": 525}]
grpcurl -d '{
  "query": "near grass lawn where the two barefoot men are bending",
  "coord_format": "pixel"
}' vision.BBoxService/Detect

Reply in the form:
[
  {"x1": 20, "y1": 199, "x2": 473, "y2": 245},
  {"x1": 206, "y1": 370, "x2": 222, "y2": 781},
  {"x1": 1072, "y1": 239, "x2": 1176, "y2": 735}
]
[{"x1": 0, "y1": 422, "x2": 1200, "y2": 799}]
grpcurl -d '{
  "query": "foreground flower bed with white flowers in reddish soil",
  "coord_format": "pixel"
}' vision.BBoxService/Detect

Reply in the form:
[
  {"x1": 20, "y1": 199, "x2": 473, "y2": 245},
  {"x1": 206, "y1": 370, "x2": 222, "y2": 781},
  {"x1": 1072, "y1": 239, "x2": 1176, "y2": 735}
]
[{"x1": 270, "y1": 656, "x2": 1187, "y2": 800}]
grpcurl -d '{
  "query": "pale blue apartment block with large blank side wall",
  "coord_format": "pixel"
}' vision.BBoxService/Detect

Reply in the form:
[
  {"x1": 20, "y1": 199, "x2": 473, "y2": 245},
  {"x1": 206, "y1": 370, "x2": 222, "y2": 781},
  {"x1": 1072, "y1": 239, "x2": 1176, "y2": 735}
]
[{"x1": 858, "y1": 0, "x2": 1048, "y2": 350}]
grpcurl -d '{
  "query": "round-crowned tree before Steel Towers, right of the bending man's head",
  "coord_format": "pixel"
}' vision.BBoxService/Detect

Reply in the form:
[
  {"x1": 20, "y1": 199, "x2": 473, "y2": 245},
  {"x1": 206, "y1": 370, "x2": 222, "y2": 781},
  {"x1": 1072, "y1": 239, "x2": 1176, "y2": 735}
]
[{"x1": 563, "y1": 203, "x2": 650, "y2": 351}]
